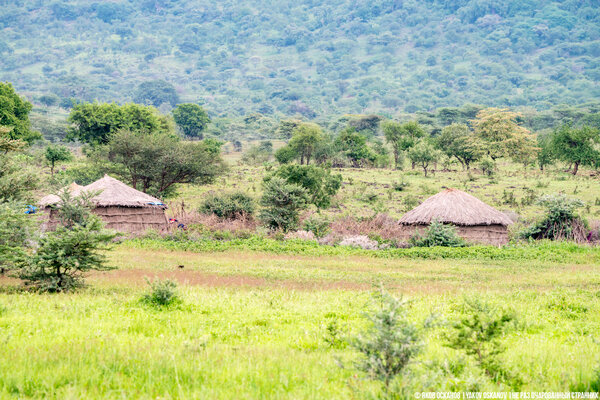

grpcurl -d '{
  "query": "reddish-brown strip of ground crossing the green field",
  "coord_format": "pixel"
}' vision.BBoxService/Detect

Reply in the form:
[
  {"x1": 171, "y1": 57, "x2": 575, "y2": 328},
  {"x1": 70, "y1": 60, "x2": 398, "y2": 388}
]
[{"x1": 88, "y1": 269, "x2": 373, "y2": 290}]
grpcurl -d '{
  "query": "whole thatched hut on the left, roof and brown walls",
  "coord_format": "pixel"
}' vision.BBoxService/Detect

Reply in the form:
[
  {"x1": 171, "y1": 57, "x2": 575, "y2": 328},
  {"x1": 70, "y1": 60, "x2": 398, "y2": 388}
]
[{"x1": 39, "y1": 175, "x2": 168, "y2": 233}]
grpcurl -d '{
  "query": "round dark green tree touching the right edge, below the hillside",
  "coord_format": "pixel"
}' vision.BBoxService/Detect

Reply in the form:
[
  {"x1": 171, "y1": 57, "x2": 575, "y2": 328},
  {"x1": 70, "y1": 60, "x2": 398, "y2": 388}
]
[{"x1": 552, "y1": 125, "x2": 600, "y2": 175}]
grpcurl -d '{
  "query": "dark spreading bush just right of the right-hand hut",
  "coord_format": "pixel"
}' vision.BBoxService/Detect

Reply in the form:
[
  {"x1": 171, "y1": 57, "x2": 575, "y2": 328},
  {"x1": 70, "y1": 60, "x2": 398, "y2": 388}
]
[{"x1": 518, "y1": 194, "x2": 587, "y2": 242}]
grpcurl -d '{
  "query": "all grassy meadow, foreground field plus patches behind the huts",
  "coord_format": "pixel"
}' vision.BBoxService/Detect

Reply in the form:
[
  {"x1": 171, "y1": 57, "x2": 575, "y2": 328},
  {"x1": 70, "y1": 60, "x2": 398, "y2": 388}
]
[{"x1": 0, "y1": 159, "x2": 600, "y2": 399}]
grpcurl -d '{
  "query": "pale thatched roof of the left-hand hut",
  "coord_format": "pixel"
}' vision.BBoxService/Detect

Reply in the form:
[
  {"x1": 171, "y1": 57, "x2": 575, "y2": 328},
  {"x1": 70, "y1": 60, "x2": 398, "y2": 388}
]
[{"x1": 40, "y1": 175, "x2": 166, "y2": 208}]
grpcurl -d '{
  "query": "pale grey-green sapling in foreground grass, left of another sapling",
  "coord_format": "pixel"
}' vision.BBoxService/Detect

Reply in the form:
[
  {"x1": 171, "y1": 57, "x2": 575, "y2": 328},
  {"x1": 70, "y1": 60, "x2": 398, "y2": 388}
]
[{"x1": 350, "y1": 290, "x2": 424, "y2": 393}]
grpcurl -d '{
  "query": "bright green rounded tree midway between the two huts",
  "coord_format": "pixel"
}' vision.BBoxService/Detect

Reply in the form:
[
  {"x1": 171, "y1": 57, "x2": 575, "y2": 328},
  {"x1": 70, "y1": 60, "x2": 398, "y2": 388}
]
[{"x1": 266, "y1": 164, "x2": 342, "y2": 208}]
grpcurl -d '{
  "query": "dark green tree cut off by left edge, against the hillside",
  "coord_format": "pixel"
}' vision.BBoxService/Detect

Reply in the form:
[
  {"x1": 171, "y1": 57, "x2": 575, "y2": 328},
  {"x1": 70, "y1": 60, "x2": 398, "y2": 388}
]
[{"x1": 0, "y1": 82, "x2": 42, "y2": 144}]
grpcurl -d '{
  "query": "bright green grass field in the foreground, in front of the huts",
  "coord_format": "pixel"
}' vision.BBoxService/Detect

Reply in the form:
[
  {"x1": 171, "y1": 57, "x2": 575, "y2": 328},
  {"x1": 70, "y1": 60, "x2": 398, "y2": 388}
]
[{"x1": 0, "y1": 242, "x2": 600, "y2": 399}]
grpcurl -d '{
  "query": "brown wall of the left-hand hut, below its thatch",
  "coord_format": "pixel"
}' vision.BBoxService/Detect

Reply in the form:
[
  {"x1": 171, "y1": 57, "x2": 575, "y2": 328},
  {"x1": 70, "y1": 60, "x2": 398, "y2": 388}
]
[{"x1": 43, "y1": 207, "x2": 168, "y2": 233}]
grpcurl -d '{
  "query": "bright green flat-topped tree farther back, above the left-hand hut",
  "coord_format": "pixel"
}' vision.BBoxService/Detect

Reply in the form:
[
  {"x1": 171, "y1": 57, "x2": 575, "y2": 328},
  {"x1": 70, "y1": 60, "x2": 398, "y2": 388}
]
[{"x1": 67, "y1": 103, "x2": 172, "y2": 145}]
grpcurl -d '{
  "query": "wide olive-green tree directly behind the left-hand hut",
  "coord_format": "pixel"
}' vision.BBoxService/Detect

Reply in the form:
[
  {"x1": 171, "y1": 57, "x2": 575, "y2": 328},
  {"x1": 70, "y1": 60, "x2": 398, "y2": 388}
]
[{"x1": 108, "y1": 130, "x2": 225, "y2": 196}]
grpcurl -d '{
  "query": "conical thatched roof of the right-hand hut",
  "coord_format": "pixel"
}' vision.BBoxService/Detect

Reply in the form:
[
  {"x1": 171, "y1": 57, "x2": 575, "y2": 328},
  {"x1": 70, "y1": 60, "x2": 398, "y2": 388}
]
[{"x1": 400, "y1": 189, "x2": 512, "y2": 226}]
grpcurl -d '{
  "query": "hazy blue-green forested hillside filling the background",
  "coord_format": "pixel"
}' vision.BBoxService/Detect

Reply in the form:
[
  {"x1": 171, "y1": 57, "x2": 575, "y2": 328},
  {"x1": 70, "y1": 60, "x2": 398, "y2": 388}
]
[{"x1": 0, "y1": 0, "x2": 600, "y2": 118}]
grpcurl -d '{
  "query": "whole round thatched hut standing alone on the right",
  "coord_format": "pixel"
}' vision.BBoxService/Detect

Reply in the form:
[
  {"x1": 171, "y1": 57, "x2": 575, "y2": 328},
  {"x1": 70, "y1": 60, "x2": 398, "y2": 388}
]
[{"x1": 399, "y1": 189, "x2": 512, "y2": 246}]
